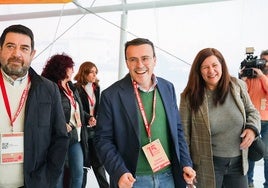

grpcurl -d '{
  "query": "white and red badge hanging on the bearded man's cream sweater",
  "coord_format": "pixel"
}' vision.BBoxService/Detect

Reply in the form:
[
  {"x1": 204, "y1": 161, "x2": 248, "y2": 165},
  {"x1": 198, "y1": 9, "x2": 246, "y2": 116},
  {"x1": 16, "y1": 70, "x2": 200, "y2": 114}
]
[{"x1": 0, "y1": 132, "x2": 24, "y2": 164}]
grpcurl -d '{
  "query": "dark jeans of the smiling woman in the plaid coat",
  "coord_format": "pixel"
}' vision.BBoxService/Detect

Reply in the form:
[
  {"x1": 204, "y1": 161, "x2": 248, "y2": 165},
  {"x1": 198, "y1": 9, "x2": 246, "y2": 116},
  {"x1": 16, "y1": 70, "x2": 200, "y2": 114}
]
[{"x1": 213, "y1": 156, "x2": 248, "y2": 188}]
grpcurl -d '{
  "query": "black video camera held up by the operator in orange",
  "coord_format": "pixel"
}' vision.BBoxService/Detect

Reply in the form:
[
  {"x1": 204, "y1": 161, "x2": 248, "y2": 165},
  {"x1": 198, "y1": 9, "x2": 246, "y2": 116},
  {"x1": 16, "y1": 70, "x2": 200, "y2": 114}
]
[{"x1": 240, "y1": 47, "x2": 266, "y2": 78}]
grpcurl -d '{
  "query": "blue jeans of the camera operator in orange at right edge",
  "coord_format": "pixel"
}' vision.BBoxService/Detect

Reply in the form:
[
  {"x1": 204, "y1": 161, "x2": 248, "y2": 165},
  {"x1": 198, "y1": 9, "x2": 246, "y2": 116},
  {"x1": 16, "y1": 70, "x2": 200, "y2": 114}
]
[{"x1": 248, "y1": 121, "x2": 268, "y2": 188}]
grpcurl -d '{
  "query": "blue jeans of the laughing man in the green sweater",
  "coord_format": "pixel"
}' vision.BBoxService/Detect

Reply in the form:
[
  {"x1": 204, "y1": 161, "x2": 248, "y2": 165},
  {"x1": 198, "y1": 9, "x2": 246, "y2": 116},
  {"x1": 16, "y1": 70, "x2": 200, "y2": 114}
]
[{"x1": 133, "y1": 170, "x2": 175, "y2": 188}]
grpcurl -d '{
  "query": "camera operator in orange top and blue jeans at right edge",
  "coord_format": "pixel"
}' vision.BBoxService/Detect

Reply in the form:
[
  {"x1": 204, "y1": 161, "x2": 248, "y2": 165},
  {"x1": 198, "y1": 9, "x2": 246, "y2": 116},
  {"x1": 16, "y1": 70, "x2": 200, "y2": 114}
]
[{"x1": 241, "y1": 50, "x2": 268, "y2": 188}]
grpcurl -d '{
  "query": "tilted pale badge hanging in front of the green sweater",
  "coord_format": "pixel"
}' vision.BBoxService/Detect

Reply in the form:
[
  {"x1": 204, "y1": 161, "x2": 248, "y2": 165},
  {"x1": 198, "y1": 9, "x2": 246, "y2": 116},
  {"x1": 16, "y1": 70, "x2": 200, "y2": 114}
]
[{"x1": 142, "y1": 139, "x2": 170, "y2": 172}]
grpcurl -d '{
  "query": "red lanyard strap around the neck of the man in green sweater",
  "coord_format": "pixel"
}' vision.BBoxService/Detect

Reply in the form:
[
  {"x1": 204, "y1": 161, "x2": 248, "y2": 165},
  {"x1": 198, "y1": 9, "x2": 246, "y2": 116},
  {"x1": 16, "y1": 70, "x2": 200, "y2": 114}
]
[{"x1": 133, "y1": 81, "x2": 156, "y2": 142}]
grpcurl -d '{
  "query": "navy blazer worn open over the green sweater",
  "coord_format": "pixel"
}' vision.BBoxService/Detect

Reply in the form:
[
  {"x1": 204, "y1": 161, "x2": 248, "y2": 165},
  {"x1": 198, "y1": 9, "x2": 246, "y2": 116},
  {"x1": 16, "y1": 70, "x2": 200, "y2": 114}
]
[{"x1": 95, "y1": 74, "x2": 192, "y2": 188}]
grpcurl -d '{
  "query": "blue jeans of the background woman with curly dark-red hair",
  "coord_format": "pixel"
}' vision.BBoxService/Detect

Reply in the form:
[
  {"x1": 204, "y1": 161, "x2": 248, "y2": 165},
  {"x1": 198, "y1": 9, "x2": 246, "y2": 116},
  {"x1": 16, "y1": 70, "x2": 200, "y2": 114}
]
[{"x1": 56, "y1": 142, "x2": 84, "y2": 188}]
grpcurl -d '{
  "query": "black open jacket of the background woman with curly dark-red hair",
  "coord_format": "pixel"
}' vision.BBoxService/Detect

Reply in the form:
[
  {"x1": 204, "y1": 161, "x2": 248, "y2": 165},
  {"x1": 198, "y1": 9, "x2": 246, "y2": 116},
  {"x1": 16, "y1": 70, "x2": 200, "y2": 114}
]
[{"x1": 60, "y1": 82, "x2": 90, "y2": 167}]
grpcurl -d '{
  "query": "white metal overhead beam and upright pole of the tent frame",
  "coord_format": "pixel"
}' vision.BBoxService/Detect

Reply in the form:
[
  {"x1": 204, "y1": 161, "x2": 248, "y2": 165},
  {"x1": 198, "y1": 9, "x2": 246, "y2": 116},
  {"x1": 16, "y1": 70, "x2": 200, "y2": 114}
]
[{"x1": 0, "y1": 0, "x2": 231, "y2": 79}]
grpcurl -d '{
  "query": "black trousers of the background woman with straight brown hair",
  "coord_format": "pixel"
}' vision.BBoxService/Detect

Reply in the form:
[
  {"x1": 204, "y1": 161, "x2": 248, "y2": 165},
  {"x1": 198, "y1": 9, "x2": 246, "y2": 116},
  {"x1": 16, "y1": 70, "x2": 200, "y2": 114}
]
[{"x1": 82, "y1": 138, "x2": 110, "y2": 188}]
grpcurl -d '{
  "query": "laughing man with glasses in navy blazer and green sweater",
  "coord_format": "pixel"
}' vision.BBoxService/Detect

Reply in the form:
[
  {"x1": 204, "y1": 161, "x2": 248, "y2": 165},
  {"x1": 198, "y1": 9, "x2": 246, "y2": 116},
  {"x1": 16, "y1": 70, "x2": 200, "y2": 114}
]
[{"x1": 95, "y1": 38, "x2": 195, "y2": 188}]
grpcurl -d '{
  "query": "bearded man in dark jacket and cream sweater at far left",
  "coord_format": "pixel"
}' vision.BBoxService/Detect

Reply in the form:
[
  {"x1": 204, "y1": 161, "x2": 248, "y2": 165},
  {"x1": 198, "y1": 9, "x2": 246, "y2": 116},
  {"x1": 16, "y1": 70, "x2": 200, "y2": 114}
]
[{"x1": 0, "y1": 25, "x2": 69, "y2": 188}]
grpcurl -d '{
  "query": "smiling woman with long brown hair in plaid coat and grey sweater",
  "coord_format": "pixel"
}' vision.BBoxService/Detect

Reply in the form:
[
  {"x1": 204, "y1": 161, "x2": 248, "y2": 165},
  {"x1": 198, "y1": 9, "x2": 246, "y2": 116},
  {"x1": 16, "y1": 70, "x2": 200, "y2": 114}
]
[{"x1": 180, "y1": 48, "x2": 260, "y2": 188}]
